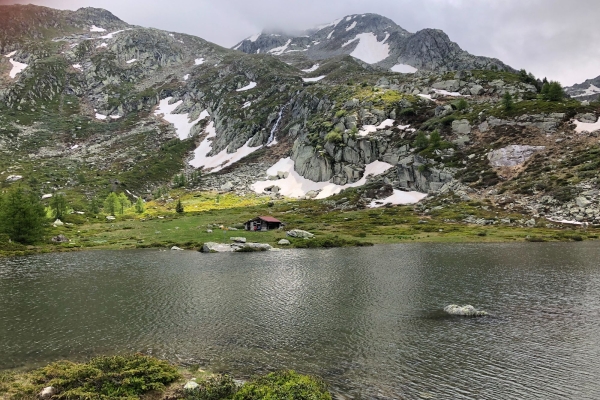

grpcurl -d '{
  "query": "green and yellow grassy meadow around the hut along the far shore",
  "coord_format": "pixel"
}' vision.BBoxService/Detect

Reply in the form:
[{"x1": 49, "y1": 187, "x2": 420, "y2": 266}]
[{"x1": 0, "y1": 191, "x2": 600, "y2": 255}]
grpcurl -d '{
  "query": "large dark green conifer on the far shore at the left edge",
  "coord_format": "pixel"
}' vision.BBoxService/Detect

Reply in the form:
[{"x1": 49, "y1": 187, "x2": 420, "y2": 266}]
[{"x1": 0, "y1": 187, "x2": 48, "y2": 244}]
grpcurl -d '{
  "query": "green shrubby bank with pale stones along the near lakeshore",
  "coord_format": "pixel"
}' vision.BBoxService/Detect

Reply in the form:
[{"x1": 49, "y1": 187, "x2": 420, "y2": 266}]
[{"x1": 0, "y1": 354, "x2": 331, "y2": 400}]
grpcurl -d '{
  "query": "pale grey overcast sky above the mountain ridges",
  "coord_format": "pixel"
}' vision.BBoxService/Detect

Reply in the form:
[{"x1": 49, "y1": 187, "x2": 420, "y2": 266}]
[{"x1": 0, "y1": 0, "x2": 600, "y2": 85}]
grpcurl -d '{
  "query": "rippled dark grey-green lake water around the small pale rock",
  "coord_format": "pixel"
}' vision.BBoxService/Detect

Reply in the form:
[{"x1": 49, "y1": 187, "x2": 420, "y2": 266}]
[{"x1": 0, "y1": 242, "x2": 600, "y2": 399}]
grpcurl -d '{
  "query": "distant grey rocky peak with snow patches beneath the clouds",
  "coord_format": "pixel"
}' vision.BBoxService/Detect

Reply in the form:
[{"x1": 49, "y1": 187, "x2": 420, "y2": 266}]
[{"x1": 233, "y1": 14, "x2": 514, "y2": 72}]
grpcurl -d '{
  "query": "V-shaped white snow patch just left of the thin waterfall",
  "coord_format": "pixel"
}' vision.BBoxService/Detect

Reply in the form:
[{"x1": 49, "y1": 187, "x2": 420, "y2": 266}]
[{"x1": 190, "y1": 121, "x2": 262, "y2": 172}]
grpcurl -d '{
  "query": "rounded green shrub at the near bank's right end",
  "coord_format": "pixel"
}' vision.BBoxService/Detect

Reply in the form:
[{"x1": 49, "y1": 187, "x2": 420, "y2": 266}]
[{"x1": 233, "y1": 371, "x2": 331, "y2": 400}]
